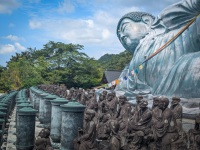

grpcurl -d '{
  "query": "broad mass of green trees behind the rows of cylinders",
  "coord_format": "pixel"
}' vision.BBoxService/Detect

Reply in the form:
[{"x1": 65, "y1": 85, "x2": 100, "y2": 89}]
[{"x1": 0, "y1": 41, "x2": 103, "y2": 91}]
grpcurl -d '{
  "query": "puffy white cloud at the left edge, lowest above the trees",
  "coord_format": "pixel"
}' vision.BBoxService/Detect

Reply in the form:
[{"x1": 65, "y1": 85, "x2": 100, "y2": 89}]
[{"x1": 0, "y1": 42, "x2": 26, "y2": 54}]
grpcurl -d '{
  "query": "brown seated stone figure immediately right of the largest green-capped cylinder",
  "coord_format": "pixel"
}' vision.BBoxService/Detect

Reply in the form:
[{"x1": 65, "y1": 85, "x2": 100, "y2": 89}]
[{"x1": 74, "y1": 109, "x2": 96, "y2": 150}]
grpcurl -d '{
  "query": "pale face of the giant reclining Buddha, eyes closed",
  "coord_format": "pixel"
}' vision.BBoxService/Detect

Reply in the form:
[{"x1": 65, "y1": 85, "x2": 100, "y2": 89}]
[{"x1": 117, "y1": 18, "x2": 149, "y2": 53}]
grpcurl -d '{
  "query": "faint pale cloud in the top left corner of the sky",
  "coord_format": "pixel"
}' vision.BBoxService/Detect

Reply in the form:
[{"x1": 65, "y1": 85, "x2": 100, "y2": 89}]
[{"x1": 0, "y1": 0, "x2": 20, "y2": 14}]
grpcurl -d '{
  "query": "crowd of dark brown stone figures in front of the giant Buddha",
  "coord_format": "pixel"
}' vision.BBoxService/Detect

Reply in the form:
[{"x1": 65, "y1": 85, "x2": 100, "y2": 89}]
[{"x1": 74, "y1": 90, "x2": 200, "y2": 150}]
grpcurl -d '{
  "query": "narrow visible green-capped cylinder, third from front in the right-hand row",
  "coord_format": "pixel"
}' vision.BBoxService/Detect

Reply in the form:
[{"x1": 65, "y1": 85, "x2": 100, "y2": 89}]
[{"x1": 43, "y1": 95, "x2": 58, "y2": 129}]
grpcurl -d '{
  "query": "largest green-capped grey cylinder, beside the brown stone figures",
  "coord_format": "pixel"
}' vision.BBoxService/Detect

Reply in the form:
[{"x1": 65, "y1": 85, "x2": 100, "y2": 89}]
[{"x1": 60, "y1": 102, "x2": 85, "y2": 150}]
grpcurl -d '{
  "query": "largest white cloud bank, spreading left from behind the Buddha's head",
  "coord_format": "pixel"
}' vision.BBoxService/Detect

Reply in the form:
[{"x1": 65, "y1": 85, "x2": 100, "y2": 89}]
[{"x1": 25, "y1": 0, "x2": 179, "y2": 58}]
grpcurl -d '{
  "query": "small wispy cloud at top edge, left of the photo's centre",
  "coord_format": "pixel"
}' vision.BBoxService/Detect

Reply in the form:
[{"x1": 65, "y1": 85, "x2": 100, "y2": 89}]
[{"x1": 57, "y1": 0, "x2": 75, "y2": 13}]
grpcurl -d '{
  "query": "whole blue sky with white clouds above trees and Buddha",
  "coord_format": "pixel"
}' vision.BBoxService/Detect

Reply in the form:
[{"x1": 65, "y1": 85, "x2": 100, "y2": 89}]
[{"x1": 0, "y1": 0, "x2": 180, "y2": 66}]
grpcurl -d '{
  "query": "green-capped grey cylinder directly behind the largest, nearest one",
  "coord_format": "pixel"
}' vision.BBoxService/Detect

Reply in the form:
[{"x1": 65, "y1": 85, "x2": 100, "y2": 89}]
[{"x1": 50, "y1": 98, "x2": 69, "y2": 143}]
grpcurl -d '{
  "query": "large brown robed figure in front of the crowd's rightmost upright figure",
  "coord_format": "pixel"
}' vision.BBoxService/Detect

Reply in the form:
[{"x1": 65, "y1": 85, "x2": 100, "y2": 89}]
[{"x1": 152, "y1": 96, "x2": 179, "y2": 150}]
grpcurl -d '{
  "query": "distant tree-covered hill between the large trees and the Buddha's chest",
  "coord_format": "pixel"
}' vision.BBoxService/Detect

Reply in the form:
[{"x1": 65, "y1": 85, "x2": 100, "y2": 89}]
[{"x1": 97, "y1": 50, "x2": 133, "y2": 70}]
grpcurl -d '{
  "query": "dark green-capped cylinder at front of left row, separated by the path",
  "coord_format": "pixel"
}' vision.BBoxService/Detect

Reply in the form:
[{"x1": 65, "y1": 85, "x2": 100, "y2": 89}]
[{"x1": 16, "y1": 107, "x2": 37, "y2": 150}]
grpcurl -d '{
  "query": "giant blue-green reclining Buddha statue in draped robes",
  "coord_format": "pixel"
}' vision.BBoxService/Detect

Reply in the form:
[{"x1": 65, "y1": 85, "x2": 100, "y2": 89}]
[{"x1": 116, "y1": 0, "x2": 200, "y2": 98}]
